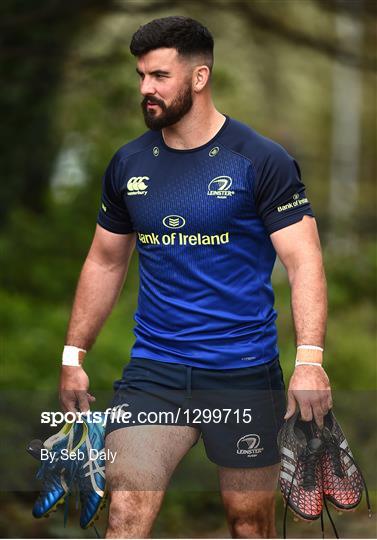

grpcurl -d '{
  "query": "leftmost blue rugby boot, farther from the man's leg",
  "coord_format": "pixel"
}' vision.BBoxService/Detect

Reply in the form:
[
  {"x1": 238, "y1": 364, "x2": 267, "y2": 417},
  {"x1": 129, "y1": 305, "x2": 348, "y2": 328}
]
[{"x1": 27, "y1": 423, "x2": 83, "y2": 518}]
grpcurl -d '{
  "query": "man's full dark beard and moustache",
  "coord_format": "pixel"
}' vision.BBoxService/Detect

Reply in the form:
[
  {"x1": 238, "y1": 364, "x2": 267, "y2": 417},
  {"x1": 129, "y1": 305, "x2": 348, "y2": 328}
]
[{"x1": 141, "y1": 83, "x2": 192, "y2": 131}]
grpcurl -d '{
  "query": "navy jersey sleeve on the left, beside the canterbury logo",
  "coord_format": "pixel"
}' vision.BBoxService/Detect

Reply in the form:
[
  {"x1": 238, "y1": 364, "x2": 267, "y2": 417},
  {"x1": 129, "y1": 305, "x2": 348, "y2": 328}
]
[{"x1": 97, "y1": 154, "x2": 133, "y2": 234}]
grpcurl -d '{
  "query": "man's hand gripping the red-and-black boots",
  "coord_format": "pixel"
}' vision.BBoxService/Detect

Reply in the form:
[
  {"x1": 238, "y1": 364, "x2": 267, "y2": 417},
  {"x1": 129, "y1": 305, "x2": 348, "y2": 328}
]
[{"x1": 284, "y1": 365, "x2": 332, "y2": 429}]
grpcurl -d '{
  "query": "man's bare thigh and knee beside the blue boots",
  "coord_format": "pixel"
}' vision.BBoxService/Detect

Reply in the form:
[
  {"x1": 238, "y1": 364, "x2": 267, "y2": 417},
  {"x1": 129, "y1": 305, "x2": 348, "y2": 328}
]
[{"x1": 106, "y1": 425, "x2": 199, "y2": 538}]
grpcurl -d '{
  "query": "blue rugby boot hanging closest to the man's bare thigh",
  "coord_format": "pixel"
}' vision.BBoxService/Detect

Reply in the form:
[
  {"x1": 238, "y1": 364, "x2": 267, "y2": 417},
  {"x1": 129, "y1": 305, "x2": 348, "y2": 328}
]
[{"x1": 75, "y1": 415, "x2": 106, "y2": 529}]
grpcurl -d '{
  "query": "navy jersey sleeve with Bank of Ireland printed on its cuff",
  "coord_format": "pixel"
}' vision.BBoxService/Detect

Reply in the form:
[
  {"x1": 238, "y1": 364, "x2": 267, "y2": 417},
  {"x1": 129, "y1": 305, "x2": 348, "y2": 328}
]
[{"x1": 254, "y1": 145, "x2": 314, "y2": 234}]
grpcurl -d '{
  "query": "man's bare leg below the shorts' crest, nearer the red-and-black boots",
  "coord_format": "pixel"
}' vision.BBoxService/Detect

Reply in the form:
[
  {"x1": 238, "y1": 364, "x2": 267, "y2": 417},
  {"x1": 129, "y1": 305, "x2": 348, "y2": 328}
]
[{"x1": 218, "y1": 464, "x2": 280, "y2": 538}]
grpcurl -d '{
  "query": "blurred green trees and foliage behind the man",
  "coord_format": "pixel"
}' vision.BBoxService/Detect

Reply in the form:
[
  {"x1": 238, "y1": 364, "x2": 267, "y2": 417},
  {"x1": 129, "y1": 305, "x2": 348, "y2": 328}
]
[{"x1": 0, "y1": 0, "x2": 377, "y2": 538}]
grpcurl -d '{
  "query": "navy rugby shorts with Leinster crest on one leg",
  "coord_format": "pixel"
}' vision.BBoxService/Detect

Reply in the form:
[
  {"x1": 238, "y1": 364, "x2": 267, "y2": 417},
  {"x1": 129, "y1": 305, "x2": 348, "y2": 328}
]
[{"x1": 106, "y1": 357, "x2": 286, "y2": 468}]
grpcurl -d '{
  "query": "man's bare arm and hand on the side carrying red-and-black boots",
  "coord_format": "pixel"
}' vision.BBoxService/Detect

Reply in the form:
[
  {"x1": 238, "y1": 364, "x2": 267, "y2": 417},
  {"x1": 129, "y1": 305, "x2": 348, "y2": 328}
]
[{"x1": 271, "y1": 216, "x2": 331, "y2": 426}]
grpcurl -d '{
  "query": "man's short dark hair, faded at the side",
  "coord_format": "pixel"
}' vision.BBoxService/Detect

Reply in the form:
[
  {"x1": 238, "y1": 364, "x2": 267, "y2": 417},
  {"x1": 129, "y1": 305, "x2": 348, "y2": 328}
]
[{"x1": 130, "y1": 16, "x2": 213, "y2": 69}]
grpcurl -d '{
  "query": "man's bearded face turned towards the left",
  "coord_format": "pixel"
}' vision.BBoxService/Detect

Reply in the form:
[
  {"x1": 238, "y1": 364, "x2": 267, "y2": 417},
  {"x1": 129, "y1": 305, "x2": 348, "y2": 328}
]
[{"x1": 136, "y1": 48, "x2": 192, "y2": 130}]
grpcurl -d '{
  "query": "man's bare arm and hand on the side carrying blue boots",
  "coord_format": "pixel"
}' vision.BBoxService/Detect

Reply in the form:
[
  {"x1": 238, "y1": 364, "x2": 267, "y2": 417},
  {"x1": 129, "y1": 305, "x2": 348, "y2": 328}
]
[{"x1": 60, "y1": 225, "x2": 135, "y2": 411}]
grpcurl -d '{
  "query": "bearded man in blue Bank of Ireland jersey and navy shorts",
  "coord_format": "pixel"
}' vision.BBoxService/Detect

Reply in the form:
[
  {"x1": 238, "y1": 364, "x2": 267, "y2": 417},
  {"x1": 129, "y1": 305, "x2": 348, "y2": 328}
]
[{"x1": 60, "y1": 17, "x2": 331, "y2": 538}]
